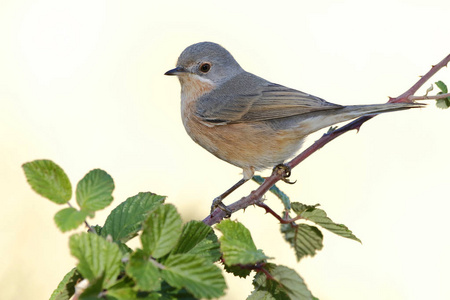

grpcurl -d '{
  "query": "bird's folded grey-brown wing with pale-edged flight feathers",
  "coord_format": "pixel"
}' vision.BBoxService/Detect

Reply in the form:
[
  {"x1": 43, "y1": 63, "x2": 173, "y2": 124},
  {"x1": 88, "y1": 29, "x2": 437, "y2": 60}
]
[{"x1": 196, "y1": 73, "x2": 342, "y2": 124}]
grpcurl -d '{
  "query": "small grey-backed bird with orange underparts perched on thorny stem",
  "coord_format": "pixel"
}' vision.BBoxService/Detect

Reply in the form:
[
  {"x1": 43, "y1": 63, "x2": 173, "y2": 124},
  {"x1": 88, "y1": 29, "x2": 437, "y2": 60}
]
[{"x1": 165, "y1": 42, "x2": 420, "y2": 211}]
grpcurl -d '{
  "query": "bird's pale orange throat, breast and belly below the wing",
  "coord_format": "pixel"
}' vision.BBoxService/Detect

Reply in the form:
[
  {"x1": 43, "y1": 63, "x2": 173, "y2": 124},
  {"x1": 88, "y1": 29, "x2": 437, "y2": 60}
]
[{"x1": 180, "y1": 75, "x2": 302, "y2": 170}]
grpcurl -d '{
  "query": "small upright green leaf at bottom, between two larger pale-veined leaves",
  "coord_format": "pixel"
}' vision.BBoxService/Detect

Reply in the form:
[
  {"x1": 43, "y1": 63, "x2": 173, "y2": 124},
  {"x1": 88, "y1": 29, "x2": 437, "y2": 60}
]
[{"x1": 127, "y1": 249, "x2": 161, "y2": 291}]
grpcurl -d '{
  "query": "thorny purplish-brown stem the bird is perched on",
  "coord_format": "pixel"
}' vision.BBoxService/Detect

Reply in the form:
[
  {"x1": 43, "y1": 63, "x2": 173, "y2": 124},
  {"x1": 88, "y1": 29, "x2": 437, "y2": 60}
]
[{"x1": 203, "y1": 54, "x2": 450, "y2": 226}]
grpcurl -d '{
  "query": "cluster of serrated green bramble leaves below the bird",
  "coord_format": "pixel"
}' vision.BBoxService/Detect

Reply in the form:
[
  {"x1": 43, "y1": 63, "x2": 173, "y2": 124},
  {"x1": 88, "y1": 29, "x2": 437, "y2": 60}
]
[{"x1": 23, "y1": 160, "x2": 359, "y2": 300}]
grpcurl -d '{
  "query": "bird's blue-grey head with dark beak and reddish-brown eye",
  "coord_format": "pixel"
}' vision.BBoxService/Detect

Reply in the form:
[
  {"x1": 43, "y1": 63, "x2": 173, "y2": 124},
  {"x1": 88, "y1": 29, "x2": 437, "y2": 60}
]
[{"x1": 164, "y1": 42, "x2": 244, "y2": 85}]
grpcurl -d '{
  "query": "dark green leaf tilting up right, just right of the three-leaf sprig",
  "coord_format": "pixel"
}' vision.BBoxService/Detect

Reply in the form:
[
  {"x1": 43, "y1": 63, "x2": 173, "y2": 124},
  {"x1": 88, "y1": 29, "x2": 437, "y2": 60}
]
[{"x1": 101, "y1": 192, "x2": 166, "y2": 243}]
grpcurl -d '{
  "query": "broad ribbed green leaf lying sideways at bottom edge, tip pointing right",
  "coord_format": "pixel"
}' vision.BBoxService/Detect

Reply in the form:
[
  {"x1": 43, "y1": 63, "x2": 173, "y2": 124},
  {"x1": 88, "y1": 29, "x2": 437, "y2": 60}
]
[{"x1": 162, "y1": 254, "x2": 226, "y2": 299}]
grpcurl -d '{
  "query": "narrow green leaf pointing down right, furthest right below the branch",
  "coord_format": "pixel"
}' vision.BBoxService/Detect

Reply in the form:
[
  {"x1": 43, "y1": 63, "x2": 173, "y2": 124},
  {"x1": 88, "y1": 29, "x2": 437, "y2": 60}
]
[{"x1": 292, "y1": 203, "x2": 361, "y2": 243}]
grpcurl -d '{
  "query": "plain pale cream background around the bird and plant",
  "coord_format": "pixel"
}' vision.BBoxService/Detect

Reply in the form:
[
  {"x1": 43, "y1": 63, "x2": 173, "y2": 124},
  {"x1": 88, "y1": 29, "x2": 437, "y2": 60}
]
[{"x1": 0, "y1": 0, "x2": 450, "y2": 299}]
